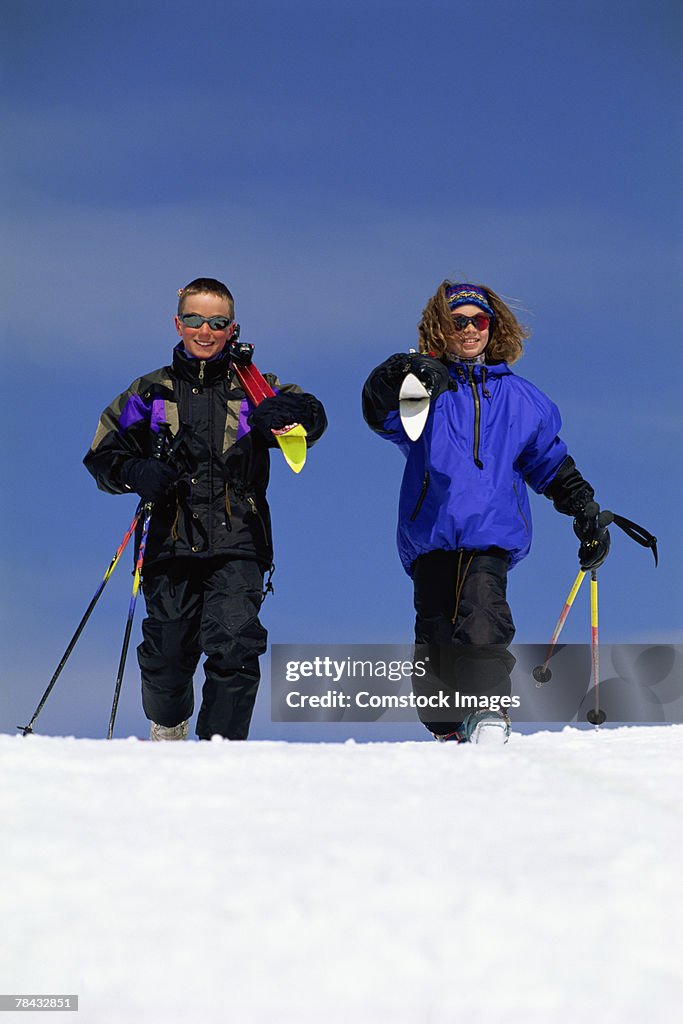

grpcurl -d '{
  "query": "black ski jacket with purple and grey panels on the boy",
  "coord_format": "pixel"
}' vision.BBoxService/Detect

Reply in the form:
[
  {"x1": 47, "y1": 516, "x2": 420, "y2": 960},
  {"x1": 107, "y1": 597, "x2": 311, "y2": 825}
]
[{"x1": 83, "y1": 344, "x2": 327, "y2": 567}]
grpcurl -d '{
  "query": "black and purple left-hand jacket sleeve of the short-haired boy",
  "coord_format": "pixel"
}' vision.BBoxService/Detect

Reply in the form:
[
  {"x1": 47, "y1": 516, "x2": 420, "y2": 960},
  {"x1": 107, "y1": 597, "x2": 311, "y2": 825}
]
[{"x1": 83, "y1": 380, "x2": 152, "y2": 495}]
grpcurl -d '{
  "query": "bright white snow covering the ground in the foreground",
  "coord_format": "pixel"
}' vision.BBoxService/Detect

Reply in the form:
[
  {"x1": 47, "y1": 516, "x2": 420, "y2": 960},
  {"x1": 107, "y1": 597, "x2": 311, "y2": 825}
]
[{"x1": 0, "y1": 726, "x2": 683, "y2": 1024}]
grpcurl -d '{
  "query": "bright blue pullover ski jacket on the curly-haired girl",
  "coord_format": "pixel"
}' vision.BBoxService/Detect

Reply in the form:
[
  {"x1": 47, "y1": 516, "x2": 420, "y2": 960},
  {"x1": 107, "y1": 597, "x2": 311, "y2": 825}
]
[{"x1": 364, "y1": 362, "x2": 567, "y2": 575}]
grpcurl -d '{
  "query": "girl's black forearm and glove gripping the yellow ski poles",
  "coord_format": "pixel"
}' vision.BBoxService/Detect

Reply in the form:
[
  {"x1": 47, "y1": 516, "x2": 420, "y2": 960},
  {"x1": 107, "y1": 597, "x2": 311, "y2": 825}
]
[{"x1": 545, "y1": 456, "x2": 613, "y2": 571}]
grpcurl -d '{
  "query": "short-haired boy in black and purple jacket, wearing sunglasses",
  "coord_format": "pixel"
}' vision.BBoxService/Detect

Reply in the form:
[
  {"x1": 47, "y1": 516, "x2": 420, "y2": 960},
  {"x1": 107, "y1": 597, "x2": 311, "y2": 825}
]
[{"x1": 84, "y1": 278, "x2": 327, "y2": 739}]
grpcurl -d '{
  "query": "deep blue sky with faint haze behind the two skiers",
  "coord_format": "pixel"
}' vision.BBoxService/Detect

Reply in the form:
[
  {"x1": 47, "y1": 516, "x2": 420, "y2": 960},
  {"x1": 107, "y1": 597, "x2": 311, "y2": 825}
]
[{"x1": 0, "y1": 0, "x2": 682, "y2": 738}]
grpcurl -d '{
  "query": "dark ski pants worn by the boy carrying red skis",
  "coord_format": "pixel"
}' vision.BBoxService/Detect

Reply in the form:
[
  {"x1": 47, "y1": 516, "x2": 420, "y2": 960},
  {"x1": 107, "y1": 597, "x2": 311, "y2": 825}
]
[{"x1": 137, "y1": 558, "x2": 267, "y2": 739}]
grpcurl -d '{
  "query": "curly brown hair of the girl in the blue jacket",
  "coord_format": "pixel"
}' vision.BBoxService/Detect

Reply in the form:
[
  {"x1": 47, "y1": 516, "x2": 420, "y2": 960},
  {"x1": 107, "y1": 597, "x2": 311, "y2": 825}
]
[{"x1": 418, "y1": 281, "x2": 530, "y2": 362}]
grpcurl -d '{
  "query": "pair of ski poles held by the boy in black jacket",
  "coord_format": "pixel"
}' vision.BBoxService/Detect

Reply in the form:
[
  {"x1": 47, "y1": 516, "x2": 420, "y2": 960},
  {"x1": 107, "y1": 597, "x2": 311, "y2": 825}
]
[{"x1": 16, "y1": 423, "x2": 175, "y2": 739}]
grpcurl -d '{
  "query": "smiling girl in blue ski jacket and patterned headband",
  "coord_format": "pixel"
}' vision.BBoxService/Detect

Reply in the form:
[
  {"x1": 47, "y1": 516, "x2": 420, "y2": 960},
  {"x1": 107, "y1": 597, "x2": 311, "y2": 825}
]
[{"x1": 362, "y1": 281, "x2": 609, "y2": 742}]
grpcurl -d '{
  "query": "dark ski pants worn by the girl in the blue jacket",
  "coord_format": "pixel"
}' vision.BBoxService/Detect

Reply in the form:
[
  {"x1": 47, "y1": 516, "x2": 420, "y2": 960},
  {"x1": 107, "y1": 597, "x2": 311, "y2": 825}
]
[{"x1": 413, "y1": 549, "x2": 515, "y2": 735}]
